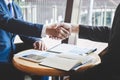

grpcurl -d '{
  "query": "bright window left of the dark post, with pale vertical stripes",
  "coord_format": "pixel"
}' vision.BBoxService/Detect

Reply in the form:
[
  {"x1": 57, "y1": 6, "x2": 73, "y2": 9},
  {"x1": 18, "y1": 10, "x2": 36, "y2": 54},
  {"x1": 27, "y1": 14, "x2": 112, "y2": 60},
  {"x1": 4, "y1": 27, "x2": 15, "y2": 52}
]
[{"x1": 15, "y1": 0, "x2": 67, "y2": 24}]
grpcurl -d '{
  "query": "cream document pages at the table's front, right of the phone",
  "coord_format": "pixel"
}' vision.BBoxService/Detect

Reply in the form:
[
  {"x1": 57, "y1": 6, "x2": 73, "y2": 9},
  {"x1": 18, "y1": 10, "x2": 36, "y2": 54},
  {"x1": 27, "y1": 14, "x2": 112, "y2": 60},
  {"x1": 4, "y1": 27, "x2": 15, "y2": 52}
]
[{"x1": 39, "y1": 54, "x2": 94, "y2": 71}]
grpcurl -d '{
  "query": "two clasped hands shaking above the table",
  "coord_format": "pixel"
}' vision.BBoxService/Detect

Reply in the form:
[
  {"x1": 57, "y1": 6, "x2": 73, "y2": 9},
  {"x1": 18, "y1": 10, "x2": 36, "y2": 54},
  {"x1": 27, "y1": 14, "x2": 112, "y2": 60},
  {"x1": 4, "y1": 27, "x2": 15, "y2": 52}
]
[{"x1": 46, "y1": 24, "x2": 70, "y2": 39}]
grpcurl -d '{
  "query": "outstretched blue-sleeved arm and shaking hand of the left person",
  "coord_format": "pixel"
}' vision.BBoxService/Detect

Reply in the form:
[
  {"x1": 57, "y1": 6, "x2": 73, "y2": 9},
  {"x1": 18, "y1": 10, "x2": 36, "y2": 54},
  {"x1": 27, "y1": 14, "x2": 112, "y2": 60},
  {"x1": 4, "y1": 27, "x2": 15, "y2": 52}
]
[{"x1": 0, "y1": 1, "x2": 67, "y2": 39}]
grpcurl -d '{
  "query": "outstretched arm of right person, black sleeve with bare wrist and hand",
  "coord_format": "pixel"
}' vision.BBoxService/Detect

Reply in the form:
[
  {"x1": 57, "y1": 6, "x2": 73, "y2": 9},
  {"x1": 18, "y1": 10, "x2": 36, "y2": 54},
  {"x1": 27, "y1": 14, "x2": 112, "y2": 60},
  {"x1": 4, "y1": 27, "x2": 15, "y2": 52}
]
[{"x1": 59, "y1": 23, "x2": 110, "y2": 42}]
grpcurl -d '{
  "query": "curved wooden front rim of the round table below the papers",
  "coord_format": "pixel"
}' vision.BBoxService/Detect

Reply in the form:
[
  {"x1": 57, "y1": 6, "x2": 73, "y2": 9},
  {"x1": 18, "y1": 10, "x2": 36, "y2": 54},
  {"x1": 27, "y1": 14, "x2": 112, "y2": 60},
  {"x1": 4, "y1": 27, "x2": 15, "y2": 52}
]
[{"x1": 13, "y1": 53, "x2": 101, "y2": 76}]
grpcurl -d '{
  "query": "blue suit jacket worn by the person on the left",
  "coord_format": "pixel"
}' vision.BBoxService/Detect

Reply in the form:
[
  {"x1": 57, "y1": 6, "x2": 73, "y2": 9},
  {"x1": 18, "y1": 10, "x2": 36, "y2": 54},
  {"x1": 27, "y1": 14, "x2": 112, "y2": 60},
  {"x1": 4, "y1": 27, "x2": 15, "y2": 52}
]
[{"x1": 0, "y1": 0, "x2": 43, "y2": 62}]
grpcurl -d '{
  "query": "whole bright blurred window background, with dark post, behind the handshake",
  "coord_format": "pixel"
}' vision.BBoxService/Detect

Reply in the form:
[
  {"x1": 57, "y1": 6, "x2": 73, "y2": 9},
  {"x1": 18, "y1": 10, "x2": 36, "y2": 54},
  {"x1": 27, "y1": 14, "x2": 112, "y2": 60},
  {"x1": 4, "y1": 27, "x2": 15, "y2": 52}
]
[{"x1": 15, "y1": 0, "x2": 120, "y2": 42}]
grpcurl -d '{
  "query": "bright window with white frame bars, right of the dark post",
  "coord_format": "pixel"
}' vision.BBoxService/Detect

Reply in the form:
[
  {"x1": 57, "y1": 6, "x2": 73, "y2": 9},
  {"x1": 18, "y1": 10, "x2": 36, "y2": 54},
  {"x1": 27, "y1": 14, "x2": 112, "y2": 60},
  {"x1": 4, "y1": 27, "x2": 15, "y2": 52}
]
[{"x1": 78, "y1": 0, "x2": 120, "y2": 27}]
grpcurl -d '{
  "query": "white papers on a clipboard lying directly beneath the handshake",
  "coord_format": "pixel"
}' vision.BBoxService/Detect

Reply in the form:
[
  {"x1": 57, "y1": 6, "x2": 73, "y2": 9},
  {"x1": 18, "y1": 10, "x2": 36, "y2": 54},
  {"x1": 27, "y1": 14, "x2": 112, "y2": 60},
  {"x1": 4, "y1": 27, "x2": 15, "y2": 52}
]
[{"x1": 48, "y1": 43, "x2": 97, "y2": 56}]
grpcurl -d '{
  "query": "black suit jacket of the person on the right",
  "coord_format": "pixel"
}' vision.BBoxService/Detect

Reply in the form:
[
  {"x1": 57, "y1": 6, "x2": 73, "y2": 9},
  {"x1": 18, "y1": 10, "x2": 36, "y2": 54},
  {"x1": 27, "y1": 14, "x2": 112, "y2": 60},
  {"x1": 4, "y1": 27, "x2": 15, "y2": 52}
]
[{"x1": 71, "y1": 4, "x2": 120, "y2": 80}]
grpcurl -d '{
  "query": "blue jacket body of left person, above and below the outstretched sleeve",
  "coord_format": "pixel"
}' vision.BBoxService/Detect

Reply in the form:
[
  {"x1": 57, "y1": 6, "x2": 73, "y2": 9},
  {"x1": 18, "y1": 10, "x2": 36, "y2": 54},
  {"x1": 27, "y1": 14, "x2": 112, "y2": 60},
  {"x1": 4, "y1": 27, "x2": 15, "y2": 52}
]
[{"x1": 0, "y1": 0, "x2": 22, "y2": 62}]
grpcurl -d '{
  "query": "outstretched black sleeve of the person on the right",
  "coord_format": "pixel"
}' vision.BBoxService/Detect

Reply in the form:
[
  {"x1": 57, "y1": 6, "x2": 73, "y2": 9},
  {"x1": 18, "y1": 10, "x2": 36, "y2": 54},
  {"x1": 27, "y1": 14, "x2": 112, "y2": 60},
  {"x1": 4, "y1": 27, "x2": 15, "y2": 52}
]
[{"x1": 79, "y1": 25, "x2": 110, "y2": 42}]
